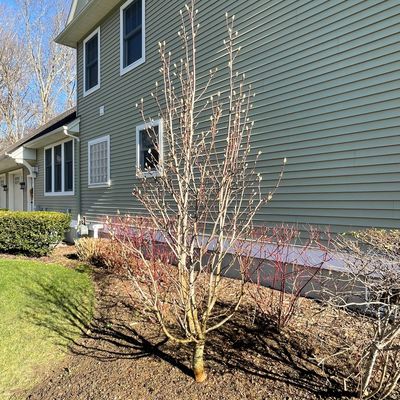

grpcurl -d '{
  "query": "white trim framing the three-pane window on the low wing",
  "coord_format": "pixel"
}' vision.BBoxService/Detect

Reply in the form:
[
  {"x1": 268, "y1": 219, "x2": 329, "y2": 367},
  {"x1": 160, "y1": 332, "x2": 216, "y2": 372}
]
[{"x1": 43, "y1": 139, "x2": 75, "y2": 197}]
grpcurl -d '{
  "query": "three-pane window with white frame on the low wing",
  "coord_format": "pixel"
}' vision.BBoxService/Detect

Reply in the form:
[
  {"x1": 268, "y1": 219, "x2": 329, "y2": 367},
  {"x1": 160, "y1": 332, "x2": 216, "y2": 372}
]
[{"x1": 44, "y1": 140, "x2": 74, "y2": 195}]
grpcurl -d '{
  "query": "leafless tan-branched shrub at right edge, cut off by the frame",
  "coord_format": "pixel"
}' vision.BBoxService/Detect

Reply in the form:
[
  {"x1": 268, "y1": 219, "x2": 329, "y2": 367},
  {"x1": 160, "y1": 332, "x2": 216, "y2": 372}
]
[{"x1": 324, "y1": 229, "x2": 400, "y2": 399}]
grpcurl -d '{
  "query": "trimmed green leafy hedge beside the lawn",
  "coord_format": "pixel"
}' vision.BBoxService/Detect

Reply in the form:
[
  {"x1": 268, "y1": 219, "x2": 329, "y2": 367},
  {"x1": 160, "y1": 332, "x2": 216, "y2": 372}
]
[{"x1": 0, "y1": 211, "x2": 71, "y2": 257}]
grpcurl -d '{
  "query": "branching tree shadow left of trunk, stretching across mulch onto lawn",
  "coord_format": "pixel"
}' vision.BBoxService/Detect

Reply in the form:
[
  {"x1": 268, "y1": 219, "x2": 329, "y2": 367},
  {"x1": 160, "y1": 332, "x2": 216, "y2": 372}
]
[{"x1": 25, "y1": 273, "x2": 192, "y2": 376}]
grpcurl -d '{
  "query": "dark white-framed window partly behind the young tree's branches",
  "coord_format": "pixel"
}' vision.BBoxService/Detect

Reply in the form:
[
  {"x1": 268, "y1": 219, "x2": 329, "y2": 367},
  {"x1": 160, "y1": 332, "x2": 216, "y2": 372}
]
[{"x1": 136, "y1": 120, "x2": 163, "y2": 177}]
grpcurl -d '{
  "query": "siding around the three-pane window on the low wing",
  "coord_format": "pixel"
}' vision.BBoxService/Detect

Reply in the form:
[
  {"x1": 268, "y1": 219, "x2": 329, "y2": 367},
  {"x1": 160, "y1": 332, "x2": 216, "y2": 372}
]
[{"x1": 35, "y1": 142, "x2": 79, "y2": 220}]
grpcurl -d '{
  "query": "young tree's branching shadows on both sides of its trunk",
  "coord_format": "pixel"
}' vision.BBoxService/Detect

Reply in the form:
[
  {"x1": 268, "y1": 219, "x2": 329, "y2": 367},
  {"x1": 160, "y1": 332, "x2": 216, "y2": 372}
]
[{"x1": 27, "y1": 272, "x2": 350, "y2": 398}]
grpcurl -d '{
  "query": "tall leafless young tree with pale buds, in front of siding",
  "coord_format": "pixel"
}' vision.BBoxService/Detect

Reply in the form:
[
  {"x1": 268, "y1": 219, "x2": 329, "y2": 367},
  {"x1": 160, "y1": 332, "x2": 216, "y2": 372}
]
[{"x1": 110, "y1": 0, "x2": 282, "y2": 382}]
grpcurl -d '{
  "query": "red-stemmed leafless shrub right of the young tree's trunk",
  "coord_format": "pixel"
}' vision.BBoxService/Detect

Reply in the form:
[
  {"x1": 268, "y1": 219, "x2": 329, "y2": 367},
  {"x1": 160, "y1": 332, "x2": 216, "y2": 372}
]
[{"x1": 250, "y1": 225, "x2": 330, "y2": 330}]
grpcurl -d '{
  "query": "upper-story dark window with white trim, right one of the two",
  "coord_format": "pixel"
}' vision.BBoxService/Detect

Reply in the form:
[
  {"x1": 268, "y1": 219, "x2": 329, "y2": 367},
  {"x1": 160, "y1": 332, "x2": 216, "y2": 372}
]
[{"x1": 120, "y1": 0, "x2": 145, "y2": 75}]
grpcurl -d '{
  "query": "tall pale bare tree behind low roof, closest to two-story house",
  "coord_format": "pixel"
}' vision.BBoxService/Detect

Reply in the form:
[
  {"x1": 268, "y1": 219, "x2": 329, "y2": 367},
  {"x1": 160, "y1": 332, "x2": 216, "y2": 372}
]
[{"x1": 19, "y1": 0, "x2": 75, "y2": 125}]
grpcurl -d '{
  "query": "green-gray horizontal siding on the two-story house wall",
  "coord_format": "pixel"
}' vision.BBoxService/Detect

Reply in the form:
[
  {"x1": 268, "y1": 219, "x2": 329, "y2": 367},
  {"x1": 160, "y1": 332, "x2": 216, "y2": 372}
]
[{"x1": 76, "y1": 0, "x2": 400, "y2": 231}]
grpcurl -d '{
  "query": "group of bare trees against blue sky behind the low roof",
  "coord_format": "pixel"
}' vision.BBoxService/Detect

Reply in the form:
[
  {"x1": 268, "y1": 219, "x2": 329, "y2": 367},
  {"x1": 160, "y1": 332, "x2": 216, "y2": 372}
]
[{"x1": 0, "y1": 0, "x2": 75, "y2": 147}]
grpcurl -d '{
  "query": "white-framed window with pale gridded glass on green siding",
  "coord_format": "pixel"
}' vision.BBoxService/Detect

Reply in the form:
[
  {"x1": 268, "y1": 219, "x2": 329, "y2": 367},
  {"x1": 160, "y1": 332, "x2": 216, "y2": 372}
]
[{"x1": 88, "y1": 136, "x2": 110, "y2": 187}]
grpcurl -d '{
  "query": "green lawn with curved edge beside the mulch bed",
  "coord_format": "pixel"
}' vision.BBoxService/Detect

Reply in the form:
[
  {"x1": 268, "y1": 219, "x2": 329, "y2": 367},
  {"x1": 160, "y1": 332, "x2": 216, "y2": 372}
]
[{"x1": 0, "y1": 259, "x2": 94, "y2": 400}]
